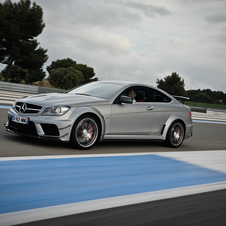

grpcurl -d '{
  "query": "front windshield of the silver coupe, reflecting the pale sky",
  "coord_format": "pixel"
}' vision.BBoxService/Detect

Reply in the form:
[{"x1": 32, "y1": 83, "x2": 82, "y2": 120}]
[{"x1": 68, "y1": 82, "x2": 123, "y2": 99}]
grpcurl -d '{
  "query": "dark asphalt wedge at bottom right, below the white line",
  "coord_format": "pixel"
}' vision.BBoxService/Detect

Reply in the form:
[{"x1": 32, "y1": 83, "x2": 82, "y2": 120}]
[{"x1": 19, "y1": 190, "x2": 226, "y2": 226}]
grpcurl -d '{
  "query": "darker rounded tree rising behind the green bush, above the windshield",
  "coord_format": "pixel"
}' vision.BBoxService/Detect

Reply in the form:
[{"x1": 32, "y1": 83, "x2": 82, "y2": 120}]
[{"x1": 46, "y1": 58, "x2": 98, "y2": 85}]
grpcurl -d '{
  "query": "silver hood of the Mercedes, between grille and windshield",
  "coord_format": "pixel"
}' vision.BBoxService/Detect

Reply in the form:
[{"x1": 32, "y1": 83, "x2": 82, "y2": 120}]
[{"x1": 17, "y1": 93, "x2": 108, "y2": 107}]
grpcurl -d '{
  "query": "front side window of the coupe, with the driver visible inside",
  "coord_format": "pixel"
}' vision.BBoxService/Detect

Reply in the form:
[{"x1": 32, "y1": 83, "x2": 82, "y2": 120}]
[{"x1": 114, "y1": 86, "x2": 149, "y2": 104}]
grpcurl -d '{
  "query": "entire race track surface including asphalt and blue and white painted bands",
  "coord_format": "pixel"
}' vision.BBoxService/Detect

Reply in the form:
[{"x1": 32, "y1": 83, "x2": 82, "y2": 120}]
[{"x1": 0, "y1": 108, "x2": 226, "y2": 225}]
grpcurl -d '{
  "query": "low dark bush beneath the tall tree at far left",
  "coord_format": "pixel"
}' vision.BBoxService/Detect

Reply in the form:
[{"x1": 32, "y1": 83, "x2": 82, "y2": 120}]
[{"x1": 1, "y1": 65, "x2": 28, "y2": 83}]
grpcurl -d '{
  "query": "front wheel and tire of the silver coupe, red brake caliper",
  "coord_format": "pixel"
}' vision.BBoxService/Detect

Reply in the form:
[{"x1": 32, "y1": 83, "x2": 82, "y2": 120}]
[{"x1": 70, "y1": 114, "x2": 100, "y2": 150}]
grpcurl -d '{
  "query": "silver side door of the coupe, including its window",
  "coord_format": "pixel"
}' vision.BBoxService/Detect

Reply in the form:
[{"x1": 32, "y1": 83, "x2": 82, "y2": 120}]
[{"x1": 109, "y1": 86, "x2": 156, "y2": 135}]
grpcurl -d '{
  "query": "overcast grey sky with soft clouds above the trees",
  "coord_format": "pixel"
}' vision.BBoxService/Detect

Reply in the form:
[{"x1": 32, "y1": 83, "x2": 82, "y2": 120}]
[{"x1": 0, "y1": 0, "x2": 226, "y2": 93}]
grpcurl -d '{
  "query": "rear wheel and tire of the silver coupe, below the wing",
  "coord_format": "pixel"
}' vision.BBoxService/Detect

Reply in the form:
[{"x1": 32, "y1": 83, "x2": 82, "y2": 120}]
[{"x1": 166, "y1": 121, "x2": 184, "y2": 148}]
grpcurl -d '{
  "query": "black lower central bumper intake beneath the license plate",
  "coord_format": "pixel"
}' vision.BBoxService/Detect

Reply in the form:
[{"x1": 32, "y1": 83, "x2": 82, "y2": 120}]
[{"x1": 9, "y1": 120, "x2": 38, "y2": 136}]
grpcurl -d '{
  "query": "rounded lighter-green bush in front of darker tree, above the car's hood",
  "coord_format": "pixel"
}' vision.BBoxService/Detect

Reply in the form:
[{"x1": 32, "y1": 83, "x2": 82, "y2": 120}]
[{"x1": 48, "y1": 67, "x2": 84, "y2": 90}]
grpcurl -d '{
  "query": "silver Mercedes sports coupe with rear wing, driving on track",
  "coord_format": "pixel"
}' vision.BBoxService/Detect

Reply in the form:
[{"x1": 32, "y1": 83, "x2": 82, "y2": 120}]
[{"x1": 4, "y1": 81, "x2": 193, "y2": 149}]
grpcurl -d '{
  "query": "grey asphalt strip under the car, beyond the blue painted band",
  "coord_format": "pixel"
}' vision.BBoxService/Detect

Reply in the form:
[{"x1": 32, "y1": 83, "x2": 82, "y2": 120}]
[{"x1": 0, "y1": 109, "x2": 226, "y2": 157}]
